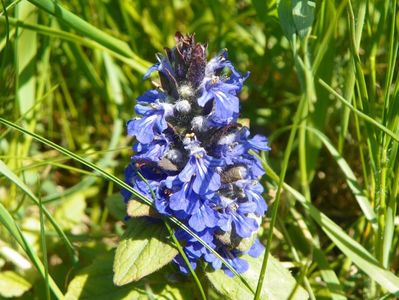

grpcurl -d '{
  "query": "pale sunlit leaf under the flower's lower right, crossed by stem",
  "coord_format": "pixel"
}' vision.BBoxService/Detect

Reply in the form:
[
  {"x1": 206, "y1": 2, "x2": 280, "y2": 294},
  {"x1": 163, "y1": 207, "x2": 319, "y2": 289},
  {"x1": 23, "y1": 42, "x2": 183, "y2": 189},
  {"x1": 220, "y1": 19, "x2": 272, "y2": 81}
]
[{"x1": 206, "y1": 255, "x2": 308, "y2": 300}]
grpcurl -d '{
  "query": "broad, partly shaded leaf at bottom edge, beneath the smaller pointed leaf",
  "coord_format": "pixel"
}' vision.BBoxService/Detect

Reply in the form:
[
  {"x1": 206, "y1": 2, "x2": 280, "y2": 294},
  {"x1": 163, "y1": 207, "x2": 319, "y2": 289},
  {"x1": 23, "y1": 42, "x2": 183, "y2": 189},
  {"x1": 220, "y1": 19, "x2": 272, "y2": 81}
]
[{"x1": 65, "y1": 252, "x2": 192, "y2": 300}]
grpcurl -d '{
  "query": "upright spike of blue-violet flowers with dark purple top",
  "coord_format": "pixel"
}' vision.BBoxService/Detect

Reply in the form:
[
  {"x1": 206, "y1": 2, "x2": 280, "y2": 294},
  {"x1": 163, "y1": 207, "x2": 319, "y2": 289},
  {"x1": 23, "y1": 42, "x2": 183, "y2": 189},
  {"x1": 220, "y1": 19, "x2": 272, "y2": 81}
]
[{"x1": 124, "y1": 33, "x2": 269, "y2": 273}]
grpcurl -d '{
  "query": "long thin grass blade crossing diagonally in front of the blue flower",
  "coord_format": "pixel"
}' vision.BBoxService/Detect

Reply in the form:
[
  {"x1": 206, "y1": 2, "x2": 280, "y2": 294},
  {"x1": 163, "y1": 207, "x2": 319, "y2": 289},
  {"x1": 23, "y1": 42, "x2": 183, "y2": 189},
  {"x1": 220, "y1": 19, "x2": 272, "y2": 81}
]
[{"x1": 0, "y1": 117, "x2": 254, "y2": 293}]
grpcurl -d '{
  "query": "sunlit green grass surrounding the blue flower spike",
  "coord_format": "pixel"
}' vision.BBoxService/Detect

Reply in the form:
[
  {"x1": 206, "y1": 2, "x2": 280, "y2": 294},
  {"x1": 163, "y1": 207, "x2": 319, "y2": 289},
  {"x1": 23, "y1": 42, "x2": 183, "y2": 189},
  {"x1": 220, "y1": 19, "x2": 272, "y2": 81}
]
[{"x1": 0, "y1": 0, "x2": 399, "y2": 299}]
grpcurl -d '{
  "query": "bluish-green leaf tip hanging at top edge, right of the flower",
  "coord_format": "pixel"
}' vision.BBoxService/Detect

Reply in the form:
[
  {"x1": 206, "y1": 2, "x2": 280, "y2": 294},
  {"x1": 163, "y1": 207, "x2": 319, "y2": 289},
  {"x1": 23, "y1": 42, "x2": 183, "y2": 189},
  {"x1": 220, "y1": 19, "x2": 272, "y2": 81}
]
[{"x1": 292, "y1": 0, "x2": 316, "y2": 39}]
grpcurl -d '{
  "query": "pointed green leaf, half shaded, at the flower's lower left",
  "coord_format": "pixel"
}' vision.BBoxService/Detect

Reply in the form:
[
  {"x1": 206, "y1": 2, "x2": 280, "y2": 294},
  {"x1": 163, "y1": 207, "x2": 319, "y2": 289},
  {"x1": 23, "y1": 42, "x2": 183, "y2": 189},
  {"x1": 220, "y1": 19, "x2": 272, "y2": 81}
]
[{"x1": 114, "y1": 219, "x2": 178, "y2": 286}]
